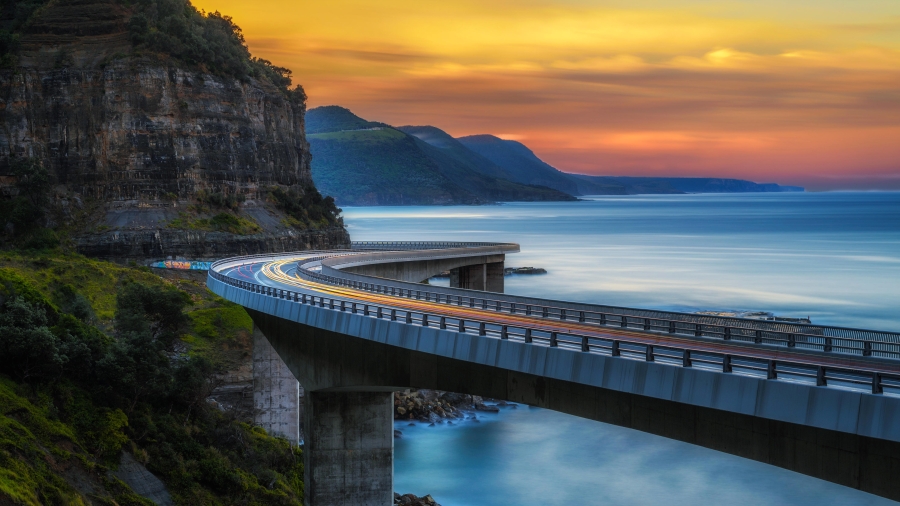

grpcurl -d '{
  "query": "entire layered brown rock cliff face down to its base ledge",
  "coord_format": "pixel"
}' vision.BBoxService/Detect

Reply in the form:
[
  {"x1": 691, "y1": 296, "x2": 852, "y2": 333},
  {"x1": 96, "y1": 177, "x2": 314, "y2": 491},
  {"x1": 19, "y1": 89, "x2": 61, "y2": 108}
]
[{"x1": 0, "y1": 0, "x2": 349, "y2": 257}]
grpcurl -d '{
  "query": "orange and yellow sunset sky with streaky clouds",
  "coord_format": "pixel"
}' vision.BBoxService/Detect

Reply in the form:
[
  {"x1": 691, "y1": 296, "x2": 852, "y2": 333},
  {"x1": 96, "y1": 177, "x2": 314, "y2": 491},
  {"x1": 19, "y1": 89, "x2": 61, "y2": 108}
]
[{"x1": 194, "y1": 0, "x2": 900, "y2": 190}]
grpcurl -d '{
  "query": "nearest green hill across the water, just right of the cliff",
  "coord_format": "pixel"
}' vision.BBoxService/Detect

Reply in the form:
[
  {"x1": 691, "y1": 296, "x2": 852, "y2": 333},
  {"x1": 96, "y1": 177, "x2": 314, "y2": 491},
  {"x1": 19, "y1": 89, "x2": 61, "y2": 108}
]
[{"x1": 306, "y1": 106, "x2": 574, "y2": 205}]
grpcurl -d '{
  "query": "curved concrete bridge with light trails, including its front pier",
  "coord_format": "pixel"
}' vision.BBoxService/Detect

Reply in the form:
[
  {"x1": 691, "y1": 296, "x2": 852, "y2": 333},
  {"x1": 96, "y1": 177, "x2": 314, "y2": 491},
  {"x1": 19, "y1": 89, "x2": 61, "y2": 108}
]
[{"x1": 208, "y1": 243, "x2": 900, "y2": 506}]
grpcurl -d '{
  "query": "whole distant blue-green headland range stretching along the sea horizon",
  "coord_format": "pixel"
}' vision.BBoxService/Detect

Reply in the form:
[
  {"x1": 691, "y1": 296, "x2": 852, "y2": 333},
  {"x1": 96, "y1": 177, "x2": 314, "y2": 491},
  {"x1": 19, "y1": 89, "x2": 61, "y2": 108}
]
[{"x1": 306, "y1": 106, "x2": 804, "y2": 206}]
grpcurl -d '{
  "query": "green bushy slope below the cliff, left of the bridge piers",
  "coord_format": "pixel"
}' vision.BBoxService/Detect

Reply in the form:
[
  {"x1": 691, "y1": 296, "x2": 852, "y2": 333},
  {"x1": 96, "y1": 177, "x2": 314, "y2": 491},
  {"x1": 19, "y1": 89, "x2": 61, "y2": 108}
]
[{"x1": 0, "y1": 251, "x2": 302, "y2": 504}]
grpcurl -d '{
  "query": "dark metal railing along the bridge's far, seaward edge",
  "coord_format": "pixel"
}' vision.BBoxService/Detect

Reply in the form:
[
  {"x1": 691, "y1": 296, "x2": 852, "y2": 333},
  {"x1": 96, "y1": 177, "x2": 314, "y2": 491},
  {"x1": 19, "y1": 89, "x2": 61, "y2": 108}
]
[{"x1": 297, "y1": 257, "x2": 900, "y2": 359}]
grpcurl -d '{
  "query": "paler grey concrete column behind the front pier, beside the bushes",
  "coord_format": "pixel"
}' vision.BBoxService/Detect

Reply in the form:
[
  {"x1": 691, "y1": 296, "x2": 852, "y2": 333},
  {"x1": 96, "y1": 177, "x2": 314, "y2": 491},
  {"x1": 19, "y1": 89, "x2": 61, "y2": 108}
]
[{"x1": 253, "y1": 326, "x2": 303, "y2": 444}]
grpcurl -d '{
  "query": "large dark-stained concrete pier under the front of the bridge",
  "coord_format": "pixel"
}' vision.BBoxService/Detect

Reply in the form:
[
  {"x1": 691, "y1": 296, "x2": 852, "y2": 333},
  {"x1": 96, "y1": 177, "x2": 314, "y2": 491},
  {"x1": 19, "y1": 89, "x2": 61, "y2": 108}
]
[{"x1": 303, "y1": 391, "x2": 394, "y2": 506}]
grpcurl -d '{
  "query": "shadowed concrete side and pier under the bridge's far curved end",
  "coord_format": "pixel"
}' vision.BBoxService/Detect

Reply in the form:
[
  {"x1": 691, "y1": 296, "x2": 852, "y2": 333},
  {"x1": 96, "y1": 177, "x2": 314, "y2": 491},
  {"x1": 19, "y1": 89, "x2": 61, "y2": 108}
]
[{"x1": 341, "y1": 255, "x2": 505, "y2": 293}]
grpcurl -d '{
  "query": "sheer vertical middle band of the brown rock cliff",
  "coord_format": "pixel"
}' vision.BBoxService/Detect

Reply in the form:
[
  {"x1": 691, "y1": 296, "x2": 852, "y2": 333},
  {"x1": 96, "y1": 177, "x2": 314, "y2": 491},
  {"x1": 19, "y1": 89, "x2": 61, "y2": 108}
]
[{"x1": 0, "y1": 63, "x2": 312, "y2": 202}]
